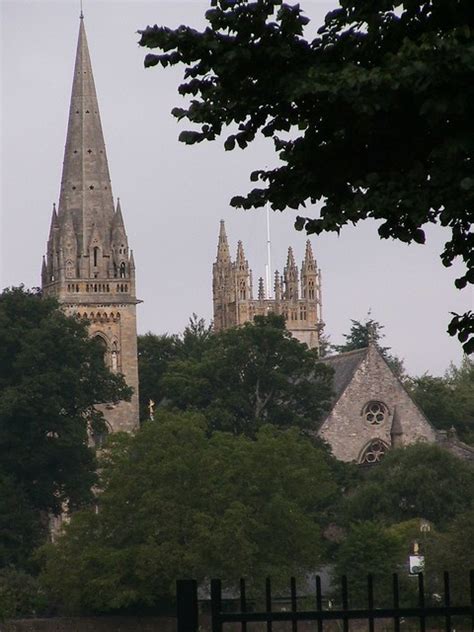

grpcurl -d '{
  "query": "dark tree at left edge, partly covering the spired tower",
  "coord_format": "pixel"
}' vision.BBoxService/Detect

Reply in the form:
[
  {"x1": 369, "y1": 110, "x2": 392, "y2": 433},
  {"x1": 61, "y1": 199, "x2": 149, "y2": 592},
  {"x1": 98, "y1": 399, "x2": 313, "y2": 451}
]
[{"x1": 0, "y1": 288, "x2": 130, "y2": 552}]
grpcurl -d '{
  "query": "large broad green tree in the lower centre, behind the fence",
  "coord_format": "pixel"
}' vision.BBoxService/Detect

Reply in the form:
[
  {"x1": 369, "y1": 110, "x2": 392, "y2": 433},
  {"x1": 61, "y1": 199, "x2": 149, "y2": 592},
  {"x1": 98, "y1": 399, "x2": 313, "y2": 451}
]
[{"x1": 42, "y1": 411, "x2": 337, "y2": 612}]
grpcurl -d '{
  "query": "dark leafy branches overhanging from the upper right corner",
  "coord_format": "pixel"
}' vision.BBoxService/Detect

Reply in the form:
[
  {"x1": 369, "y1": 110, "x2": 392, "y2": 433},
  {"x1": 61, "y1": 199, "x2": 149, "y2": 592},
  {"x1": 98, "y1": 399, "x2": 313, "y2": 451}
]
[{"x1": 140, "y1": 0, "x2": 474, "y2": 353}]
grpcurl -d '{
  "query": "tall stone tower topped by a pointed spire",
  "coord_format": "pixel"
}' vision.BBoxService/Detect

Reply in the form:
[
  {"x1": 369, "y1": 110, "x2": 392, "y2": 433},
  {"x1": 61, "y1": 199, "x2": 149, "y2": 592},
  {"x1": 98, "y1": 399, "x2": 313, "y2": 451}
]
[{"x1": 41, "y1": 15, "x2": 138, "y2": 431}]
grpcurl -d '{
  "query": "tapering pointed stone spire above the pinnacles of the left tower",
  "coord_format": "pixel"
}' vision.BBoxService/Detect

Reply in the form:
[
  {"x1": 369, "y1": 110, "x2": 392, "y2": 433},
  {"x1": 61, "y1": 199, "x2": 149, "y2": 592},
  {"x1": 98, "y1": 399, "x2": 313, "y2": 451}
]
[{"x1": 58, "y1": 19, "x2": 114, "y2": 255}]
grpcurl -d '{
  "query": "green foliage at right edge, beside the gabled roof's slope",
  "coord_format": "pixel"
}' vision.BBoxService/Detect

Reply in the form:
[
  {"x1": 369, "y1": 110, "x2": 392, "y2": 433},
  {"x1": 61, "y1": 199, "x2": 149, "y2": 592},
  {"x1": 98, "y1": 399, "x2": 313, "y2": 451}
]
[{"x1": 408, "y1": 357, "x2": 474, "y2": 445}]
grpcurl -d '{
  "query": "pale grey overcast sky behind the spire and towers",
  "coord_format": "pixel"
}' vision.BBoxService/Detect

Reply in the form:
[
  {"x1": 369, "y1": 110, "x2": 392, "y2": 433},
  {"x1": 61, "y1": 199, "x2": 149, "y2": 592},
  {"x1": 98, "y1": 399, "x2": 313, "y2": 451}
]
[{"x1": 0, "y1": 0, "x2": 473, "y2": 374}]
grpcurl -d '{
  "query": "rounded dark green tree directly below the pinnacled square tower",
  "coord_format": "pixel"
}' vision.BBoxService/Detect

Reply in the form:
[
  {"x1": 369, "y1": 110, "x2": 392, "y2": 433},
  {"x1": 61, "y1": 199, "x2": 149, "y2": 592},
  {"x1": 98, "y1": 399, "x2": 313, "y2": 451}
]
[{"x1": 161, "y1": 314, "x2": 332, "y2": 436}]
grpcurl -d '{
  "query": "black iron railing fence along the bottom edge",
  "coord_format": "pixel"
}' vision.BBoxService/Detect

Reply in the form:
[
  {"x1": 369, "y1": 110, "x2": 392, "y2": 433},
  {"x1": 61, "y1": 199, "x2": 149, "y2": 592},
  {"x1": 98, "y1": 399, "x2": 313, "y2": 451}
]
[{"x1": 177, "y1": 571, "x2": 474, "y2": 632}]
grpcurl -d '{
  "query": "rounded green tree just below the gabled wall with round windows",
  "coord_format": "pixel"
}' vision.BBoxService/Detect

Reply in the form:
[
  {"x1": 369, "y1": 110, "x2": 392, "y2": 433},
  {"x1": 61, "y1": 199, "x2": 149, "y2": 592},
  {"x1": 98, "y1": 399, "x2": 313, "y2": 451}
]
[{"x1": 345, "y1": 444, "x2": 474, "y2": 526}]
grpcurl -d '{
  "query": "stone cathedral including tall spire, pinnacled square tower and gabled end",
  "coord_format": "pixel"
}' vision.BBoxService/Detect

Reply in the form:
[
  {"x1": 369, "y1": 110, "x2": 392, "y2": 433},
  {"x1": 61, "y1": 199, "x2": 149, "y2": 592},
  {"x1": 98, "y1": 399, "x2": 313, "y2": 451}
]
[{"x1": 41, "y1": 15, "x2": 474, "y2": 465}]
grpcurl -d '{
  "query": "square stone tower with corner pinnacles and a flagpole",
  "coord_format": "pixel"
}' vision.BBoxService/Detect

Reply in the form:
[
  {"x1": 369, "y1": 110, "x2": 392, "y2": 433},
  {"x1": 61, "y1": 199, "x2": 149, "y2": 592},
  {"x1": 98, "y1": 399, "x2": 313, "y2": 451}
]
[{"x1": 212, "y1": 221, "x2": 324, "y2": 348}]
